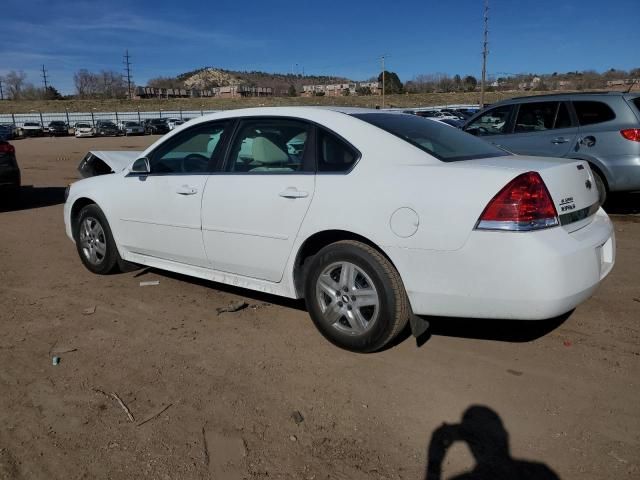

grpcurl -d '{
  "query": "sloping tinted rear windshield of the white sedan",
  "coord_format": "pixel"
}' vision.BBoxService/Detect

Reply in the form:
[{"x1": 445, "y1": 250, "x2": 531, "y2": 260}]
[{"x1": 353, "y1": 113, "x2": 509, "y2": 162}]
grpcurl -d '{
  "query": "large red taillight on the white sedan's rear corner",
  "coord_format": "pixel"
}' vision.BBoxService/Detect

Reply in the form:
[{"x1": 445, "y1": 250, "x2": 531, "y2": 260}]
[{"x1": 476, "y1": 172, "x2": 558, "y2": 231}]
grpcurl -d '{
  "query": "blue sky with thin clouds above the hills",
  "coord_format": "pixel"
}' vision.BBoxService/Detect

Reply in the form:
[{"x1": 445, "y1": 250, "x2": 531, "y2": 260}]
[{"x1": 0, "y1": 0, "x2": 640, "y2": 93}]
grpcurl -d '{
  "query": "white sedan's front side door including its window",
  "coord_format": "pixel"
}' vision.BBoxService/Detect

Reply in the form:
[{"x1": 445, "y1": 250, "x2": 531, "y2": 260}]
[{"x1": 110, "y1": 122, "x2": 226, "y2": 267}]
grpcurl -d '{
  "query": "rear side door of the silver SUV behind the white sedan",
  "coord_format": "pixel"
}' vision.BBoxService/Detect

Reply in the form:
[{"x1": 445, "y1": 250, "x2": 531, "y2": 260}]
[{"x1": 496, "y1": 101, "x2": 578, "y2": 157}]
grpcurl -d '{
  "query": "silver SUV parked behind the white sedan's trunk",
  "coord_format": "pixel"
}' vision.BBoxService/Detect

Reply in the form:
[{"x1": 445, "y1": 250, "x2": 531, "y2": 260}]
[{"x1": 463, "y1": 92, "x2": 640, "y2": 203}]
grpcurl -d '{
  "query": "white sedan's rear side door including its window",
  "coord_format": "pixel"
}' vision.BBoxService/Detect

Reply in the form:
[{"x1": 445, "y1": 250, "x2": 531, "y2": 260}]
[{"x1": 202, "y1": 117, "x2": 315, "y2": 282}]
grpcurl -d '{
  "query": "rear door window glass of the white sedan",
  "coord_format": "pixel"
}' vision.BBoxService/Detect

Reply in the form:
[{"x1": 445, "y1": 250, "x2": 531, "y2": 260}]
[{"x1": 225, "y1": 119, "x2": 311, "y2": 173}]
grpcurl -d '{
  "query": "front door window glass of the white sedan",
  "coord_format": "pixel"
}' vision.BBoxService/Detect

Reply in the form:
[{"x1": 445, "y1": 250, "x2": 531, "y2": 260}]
[{"x1": 149, "y1": 122, "x2": 227, "y2": 174}]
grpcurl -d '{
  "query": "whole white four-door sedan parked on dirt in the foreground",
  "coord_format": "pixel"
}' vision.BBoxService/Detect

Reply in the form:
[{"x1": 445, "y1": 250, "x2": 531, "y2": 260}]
[{"x1": 64, "y1": 107, "x2": 615, "y2": 352}]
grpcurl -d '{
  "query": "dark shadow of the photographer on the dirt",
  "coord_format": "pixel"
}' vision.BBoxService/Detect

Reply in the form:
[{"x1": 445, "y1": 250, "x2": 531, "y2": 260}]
[{"x1": 425, "y1": 405, "x2": 560, "y2": 480}]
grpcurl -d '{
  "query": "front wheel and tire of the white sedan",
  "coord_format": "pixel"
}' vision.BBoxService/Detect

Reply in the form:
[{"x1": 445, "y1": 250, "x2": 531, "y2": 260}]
[{"x1": 73, "y1": 204, "x2": 122, "y2": 275}]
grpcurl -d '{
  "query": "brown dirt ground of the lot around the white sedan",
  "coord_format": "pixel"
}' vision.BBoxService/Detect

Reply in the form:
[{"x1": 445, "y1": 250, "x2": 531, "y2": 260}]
[{"x1": 0, "y1": 137, "x2": 640, "y2": 480}]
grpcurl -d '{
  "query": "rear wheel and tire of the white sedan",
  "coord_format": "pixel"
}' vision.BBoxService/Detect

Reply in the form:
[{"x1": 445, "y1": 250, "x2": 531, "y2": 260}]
[{"x1": 304, "y1": 240, "x2": 411, "y2": 353}]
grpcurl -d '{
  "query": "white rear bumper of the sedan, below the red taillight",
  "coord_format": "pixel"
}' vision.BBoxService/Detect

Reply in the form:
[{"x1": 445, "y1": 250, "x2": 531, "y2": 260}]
[{"x1": 386, "y1": 210, "x2": 615, "y2": 320}]
